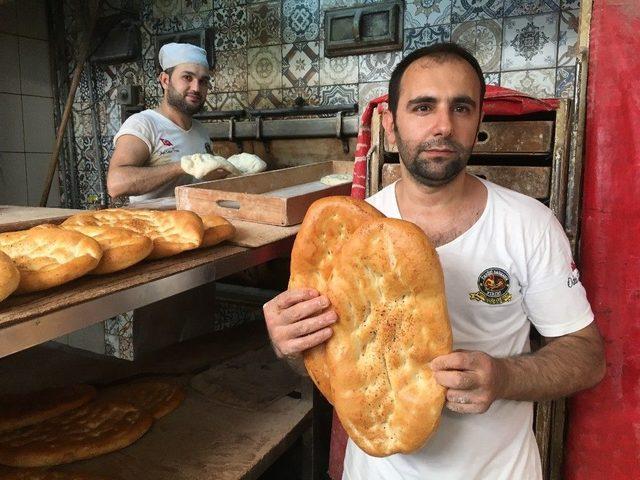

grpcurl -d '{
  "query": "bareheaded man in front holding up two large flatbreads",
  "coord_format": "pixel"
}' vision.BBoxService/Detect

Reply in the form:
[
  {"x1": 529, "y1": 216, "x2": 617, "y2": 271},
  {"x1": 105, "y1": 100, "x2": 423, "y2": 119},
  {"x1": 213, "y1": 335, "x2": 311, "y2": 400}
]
[{"x1": 264, "y1": 43, "x2": 605, "y2": 480}]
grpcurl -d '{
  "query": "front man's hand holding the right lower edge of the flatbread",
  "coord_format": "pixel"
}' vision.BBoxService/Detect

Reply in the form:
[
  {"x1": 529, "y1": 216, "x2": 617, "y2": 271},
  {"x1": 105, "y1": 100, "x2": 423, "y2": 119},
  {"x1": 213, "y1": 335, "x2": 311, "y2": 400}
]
[{"x1": 430, "y1": 350, "x2": 505, "y2": 413}]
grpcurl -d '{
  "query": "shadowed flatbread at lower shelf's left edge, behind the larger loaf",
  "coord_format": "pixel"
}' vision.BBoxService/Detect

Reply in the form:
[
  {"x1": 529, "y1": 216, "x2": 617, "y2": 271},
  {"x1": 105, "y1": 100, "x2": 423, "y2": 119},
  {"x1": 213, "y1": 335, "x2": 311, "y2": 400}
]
[{"x1": 0, "y1": 384, "x2": 96, "y2": 432}]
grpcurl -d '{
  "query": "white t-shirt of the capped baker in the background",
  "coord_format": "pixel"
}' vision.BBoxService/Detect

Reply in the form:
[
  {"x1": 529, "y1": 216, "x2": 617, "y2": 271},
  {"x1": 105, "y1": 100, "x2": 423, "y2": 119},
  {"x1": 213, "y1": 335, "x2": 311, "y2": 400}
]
[{"x1": 113, "y1": 110, "x2": 211, "y2": 202}]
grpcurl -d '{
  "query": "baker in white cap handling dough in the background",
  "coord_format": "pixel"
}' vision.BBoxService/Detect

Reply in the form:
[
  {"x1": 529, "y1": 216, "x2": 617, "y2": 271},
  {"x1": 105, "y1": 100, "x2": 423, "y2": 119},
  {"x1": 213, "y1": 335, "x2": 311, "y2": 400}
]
[{"x1": 107, "y1": 43, "x2": 230, "y2": 202}]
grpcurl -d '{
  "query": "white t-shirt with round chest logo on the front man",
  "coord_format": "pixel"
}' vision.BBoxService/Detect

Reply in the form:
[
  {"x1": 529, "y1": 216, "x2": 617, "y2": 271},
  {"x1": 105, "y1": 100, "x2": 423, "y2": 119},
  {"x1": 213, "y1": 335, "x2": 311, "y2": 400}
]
[{"x1": 342, "y1": 180, "x2": 593, "y2": 480}]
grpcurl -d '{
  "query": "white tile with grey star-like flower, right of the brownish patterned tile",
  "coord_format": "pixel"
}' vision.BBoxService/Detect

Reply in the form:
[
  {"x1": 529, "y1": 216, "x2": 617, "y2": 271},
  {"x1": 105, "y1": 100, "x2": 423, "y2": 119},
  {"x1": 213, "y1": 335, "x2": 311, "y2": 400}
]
[{"x1": 502, "y1": 13, "x2": 559, "y2": 70}]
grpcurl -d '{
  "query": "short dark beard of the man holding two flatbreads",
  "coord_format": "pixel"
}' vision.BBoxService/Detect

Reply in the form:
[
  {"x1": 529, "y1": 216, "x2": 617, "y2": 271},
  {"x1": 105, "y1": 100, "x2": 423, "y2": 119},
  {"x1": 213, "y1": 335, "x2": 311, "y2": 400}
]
[{"x1": 396, "y1": 136, "x2": 473, "y2": 187}]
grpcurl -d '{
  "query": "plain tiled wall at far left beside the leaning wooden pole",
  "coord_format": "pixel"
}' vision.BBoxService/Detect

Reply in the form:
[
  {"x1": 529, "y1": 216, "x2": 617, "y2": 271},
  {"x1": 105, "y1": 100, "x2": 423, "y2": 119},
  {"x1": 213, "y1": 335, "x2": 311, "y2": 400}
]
[{"x1": 0, "y1": 0, "x2": 60, "y2": 206}]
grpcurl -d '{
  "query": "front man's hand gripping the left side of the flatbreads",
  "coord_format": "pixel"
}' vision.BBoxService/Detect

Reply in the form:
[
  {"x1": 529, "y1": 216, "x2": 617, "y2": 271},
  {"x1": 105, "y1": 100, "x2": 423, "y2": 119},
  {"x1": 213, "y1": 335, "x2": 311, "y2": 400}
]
[{"x1": 263, "y1": 289, "x2": 338, "y2": 358}]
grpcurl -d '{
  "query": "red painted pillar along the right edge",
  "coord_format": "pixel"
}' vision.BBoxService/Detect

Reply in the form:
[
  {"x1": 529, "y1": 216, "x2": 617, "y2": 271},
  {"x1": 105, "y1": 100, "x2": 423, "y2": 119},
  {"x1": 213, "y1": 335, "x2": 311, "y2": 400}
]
[{"x1": 565, "y1": 0, "x2": 640, "y2": 480}]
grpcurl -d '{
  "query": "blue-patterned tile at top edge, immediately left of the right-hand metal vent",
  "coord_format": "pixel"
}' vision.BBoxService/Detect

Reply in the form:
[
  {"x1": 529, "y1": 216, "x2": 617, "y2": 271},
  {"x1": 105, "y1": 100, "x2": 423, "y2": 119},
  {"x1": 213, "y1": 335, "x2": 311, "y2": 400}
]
[{"x1": 282, "y1": 0, "x2": 320, "y2": 43}]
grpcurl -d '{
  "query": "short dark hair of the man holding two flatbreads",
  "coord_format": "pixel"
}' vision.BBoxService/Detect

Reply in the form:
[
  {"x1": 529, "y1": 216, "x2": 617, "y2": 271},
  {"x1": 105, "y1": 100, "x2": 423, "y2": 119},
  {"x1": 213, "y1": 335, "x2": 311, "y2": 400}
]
[{"x1": 389, "y1": 42, "x2": 486, "y2": 116}]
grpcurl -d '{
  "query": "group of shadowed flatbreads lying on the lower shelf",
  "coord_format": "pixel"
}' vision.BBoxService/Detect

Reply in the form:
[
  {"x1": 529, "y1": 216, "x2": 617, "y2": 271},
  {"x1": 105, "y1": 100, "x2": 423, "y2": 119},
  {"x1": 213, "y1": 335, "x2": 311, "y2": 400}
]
[{"x1": 0, "y1": 380, "x2": 185, "y2": 470}]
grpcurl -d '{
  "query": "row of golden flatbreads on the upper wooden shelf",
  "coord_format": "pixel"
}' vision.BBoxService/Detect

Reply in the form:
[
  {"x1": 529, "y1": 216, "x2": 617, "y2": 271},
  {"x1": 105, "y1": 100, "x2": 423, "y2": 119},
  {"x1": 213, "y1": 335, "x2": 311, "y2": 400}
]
[{"x1": 0, "y1": 209, "x2": 235, "y2": 301}]
